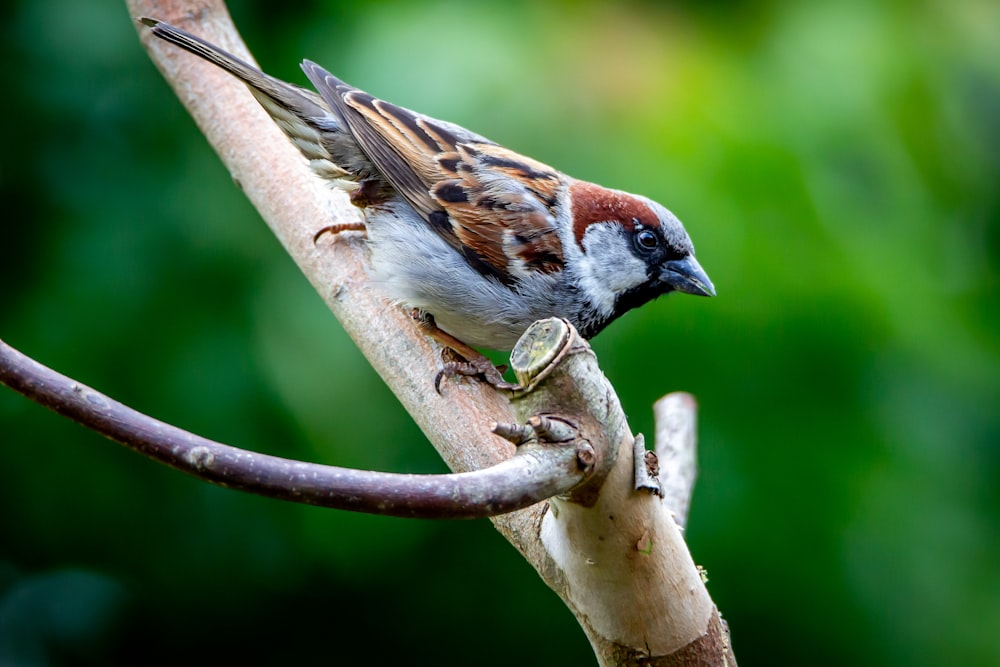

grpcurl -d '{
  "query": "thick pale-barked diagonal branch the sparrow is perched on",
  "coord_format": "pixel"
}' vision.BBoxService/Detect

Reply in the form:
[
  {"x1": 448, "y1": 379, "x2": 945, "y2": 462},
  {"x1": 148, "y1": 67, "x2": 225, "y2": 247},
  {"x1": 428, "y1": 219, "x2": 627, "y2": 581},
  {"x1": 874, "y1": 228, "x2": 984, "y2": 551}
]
[{"x1": 19, "y1": 0, "x2": 735, "y2": 665}]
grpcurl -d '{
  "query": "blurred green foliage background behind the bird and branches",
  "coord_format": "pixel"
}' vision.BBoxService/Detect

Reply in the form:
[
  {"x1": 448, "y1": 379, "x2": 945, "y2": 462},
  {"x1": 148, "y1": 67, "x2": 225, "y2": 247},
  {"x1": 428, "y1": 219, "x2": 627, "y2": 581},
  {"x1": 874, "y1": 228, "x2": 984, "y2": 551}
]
[{"x1": 0, "y1": 0, "x2": 1000, "y2": 666}]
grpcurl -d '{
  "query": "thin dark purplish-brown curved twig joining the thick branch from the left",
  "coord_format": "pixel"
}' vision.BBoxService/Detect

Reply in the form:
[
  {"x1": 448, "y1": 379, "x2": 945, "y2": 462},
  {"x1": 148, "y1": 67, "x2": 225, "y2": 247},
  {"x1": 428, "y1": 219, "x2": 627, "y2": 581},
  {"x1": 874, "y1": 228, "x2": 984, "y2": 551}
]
[{"x1": 0, "y1": 340, "x2": 587, "y2": 519}]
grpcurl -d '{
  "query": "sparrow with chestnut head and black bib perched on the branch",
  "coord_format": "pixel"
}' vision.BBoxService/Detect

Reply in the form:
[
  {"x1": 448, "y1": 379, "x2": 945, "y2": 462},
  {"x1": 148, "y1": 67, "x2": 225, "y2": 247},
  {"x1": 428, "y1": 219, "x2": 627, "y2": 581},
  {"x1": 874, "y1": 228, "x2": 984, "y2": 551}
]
[{"x1": 140, "y1": 18, "x2": 715, "y2": 390}]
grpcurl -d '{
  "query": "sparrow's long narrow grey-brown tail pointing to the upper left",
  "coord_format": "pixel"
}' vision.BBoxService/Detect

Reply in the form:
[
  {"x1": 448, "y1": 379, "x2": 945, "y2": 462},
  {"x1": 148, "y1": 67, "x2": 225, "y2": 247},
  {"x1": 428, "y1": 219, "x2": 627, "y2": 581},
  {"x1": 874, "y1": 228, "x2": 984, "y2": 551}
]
[{"x1": 145, "y1": 18, "x2": 370, "y2": 187}]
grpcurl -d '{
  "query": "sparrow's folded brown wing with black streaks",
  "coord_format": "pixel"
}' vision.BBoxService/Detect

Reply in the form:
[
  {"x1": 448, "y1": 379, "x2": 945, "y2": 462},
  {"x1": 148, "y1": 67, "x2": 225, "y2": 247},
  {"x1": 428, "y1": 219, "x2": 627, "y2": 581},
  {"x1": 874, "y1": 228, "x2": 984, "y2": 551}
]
[{"x1": 307, "y1": 62, "x2": 565, "y2": 283}]
